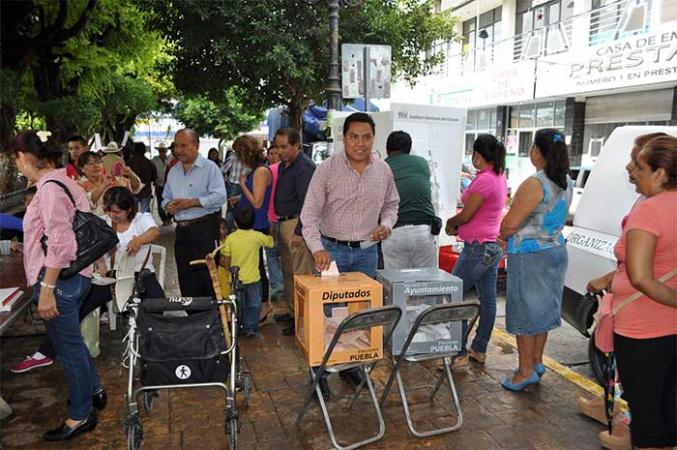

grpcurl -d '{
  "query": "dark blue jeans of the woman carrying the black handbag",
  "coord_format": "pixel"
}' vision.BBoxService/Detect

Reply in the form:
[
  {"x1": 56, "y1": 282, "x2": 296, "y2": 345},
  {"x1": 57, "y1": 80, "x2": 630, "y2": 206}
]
[{"x1": 33, "y1": 273, "x2": 101, "y2": 420}]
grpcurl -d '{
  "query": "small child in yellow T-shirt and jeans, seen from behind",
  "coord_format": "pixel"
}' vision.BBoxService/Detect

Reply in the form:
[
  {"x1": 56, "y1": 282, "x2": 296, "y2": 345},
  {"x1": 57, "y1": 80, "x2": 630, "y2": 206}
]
[{"x1": 221, "y1": 206, "x2": 274, "y2": 338}]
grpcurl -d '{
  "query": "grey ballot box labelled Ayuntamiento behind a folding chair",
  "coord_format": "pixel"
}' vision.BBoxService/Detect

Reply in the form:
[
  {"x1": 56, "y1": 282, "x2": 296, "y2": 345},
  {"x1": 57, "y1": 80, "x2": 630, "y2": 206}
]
[{"x1": 376, "y1": 267, "x2": 463, "y2": 355}]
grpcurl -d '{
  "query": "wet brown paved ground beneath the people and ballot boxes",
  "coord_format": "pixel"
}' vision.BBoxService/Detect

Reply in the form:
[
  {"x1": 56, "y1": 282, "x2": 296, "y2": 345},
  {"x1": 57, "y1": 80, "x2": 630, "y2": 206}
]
[{"x1": 0, "y1": 229, "x2": 603, "y2": 450}]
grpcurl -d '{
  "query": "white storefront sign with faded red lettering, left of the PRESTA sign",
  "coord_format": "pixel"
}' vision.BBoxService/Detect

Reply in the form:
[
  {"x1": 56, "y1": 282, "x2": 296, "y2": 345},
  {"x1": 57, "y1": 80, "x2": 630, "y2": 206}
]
[{"x1": 435, "y1": 61, "x2": 535, "y2": 108}]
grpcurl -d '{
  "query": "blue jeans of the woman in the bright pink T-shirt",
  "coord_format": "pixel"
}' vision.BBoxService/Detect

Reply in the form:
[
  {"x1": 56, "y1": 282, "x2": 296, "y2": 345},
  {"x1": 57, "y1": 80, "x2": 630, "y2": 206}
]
[{"x1": 453, "y1": 242, "x2": 503, "y2": 355}]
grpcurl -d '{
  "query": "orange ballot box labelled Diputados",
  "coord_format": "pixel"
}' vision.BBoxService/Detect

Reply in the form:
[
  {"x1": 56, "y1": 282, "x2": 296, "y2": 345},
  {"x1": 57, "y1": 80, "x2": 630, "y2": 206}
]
[{"x1": 294, "y1": 272, "x2": 383, "y2": 367}]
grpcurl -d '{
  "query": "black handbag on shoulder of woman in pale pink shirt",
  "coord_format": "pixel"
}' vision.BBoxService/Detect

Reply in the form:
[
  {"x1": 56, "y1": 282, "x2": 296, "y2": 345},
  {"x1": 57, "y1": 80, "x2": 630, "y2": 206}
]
[{"x1": 40, "y1": 180, "x2": 119, "y2": 279}]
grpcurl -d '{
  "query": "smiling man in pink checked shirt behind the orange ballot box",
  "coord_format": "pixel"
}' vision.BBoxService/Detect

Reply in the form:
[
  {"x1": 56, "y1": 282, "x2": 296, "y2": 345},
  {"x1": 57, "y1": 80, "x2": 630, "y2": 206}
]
[{"x1": 301, "y1": 113, "x2": 400, "y2": 277}]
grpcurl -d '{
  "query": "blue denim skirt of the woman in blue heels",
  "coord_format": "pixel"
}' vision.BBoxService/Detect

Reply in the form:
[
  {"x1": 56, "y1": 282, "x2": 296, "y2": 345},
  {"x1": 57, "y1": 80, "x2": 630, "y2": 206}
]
[{"x1": 505, "y1": 245, "x2": 568, "y2": 336}]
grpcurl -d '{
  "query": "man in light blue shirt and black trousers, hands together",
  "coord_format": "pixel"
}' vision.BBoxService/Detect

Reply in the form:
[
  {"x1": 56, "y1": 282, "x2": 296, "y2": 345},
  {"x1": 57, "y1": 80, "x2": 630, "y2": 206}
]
[{"x1": 162, "y1": 128, "x2": 227, "y2": 297}]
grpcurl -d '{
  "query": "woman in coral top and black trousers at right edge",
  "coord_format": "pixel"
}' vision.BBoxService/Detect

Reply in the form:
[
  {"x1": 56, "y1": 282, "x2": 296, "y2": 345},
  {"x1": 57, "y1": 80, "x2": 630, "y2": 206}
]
[{"x1": 589, "y1": 136, "x2": 677, "y2": 448}]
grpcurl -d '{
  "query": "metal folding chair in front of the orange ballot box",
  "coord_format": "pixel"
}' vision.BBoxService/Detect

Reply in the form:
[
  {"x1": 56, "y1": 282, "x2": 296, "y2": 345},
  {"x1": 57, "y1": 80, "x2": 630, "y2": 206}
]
[{"x1": 296, "y1": 306, "x2": 402, "y2": 450}]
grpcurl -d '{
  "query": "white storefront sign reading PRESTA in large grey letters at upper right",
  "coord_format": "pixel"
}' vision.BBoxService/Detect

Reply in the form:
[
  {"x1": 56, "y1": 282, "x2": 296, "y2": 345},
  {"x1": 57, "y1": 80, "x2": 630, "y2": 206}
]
[{"x1": 536, "y1": 21, "x2": 677, "y2": 98}]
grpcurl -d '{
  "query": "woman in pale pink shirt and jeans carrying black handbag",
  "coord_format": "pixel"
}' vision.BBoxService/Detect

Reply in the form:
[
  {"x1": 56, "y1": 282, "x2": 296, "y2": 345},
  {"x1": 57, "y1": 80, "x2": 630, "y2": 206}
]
[{"x1": 10, "y1": 131, "x2": 105, "y2": 441}]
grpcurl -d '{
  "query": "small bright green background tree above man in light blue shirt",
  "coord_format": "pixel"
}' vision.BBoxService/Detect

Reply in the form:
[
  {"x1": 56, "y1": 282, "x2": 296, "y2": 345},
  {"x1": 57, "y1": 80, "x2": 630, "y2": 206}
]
[{"x1": 174, "y1": 88, "x2": 263, "y2": 140}]
